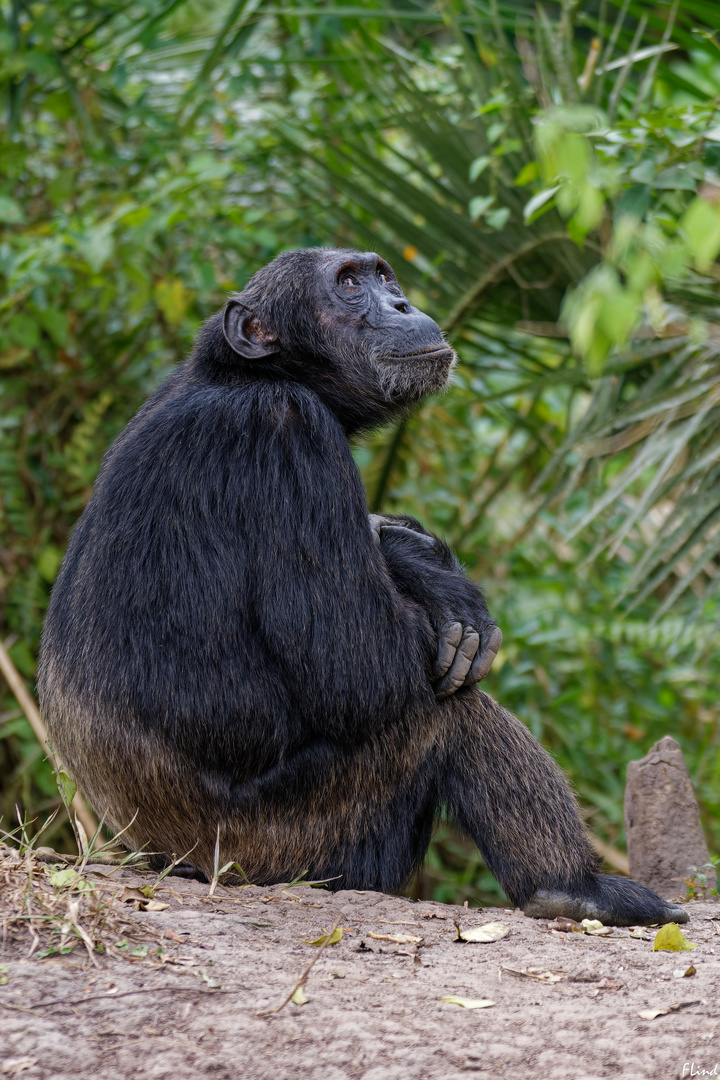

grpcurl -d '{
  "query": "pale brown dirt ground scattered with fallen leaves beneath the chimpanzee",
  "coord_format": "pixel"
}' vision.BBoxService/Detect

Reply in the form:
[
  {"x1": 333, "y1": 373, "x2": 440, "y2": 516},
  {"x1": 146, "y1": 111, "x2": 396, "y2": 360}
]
[{"x1": 0, "y1": 867, "x2": 720, "y2": 1080}]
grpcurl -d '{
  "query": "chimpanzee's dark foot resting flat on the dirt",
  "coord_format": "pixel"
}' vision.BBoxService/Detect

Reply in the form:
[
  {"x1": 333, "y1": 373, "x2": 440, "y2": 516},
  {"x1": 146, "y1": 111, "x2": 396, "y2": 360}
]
[{"x1": 522, "y1": 874, "x2": 688, "y2": 927}]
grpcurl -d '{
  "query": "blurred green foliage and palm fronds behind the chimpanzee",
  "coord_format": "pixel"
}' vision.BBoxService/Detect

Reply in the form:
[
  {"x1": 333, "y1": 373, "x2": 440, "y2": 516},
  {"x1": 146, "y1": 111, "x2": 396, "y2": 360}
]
[{"x1": 0, "y1": 0, "x2": 720, "y2": 901}]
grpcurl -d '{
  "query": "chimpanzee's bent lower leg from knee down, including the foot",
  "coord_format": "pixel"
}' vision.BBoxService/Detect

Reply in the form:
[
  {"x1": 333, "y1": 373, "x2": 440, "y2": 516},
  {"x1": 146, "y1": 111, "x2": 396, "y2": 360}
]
[{"x1": 438, "y1": 690, "x2": 688, "y2": 926}]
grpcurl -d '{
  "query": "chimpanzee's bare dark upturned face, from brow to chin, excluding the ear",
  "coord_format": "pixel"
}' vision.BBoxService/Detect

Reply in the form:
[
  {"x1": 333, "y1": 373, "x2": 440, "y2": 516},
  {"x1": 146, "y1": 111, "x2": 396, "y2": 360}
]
[{"x1": 316, "y1": 251, "x2": 456, "y2": 404}]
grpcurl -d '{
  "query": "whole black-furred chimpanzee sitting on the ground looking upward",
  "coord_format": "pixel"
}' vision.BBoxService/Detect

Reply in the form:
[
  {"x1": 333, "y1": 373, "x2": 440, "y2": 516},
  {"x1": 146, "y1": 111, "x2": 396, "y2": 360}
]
[{"x1": 39, "y1": 248, "x2": 687, "y2": 924}]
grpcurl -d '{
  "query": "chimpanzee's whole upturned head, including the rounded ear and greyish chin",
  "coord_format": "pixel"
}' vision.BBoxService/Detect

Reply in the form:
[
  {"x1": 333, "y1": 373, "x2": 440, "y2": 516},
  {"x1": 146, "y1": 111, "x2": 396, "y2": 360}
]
[{"x1": 222, "y1": 248, "x2": 456, "y2": 421}]
